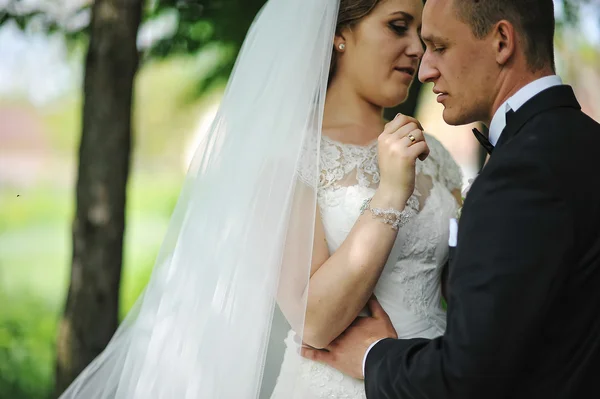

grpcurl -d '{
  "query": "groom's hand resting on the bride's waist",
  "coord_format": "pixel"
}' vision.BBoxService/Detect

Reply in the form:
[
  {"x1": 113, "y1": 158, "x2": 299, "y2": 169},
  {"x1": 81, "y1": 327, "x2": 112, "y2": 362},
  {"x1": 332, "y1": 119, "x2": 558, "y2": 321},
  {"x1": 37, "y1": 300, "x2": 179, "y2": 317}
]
[{"x1": 302, "y1": 297, "x2": 398, "y2": 379}]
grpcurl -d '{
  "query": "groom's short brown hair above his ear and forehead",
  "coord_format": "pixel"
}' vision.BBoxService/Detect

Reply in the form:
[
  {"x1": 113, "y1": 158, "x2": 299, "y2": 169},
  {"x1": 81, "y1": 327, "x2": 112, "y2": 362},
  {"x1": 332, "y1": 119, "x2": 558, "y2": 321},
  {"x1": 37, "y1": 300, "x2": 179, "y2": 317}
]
[{"x1": 454, "y1": 0, "x2": 555, "y2": 71}]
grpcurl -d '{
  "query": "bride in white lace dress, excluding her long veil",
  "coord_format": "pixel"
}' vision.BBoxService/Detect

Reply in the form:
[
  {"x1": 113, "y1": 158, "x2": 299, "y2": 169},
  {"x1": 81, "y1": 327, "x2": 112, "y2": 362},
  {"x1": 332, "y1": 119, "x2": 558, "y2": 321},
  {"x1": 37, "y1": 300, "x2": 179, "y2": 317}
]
[{"x1": 272, "y1": 0, "x2": 461, "y2": 399}]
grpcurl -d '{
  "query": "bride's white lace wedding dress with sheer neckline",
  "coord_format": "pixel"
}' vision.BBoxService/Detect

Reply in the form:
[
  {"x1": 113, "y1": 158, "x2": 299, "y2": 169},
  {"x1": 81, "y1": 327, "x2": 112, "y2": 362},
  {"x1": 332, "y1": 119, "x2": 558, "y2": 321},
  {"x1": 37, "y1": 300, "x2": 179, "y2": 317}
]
[{"x1": 271, "y1": 135, "x2": 462, "y2": 399}]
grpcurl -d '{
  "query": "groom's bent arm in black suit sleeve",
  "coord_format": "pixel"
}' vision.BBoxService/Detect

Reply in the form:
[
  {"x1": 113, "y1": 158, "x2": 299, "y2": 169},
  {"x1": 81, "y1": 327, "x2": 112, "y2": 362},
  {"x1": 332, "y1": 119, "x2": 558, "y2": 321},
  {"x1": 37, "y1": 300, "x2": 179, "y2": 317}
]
[{"x1": 365, "y1": 154, "x2": 573, "y2": 399}]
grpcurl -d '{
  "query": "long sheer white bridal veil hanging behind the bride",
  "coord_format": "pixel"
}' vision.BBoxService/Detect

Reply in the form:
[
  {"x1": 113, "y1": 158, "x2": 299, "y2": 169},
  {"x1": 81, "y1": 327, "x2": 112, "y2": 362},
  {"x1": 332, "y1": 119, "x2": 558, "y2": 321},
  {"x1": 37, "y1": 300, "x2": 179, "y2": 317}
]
[{"x1": 61, "y1": 0, "x2": 338, "y2": 399}]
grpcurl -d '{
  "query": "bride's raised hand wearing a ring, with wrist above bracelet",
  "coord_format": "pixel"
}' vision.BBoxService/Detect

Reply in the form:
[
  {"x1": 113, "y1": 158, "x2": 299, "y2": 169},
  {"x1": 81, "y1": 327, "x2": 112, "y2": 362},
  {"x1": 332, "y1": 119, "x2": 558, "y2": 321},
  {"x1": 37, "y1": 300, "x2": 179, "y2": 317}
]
[{"x1": 378, "y1": 114, "x2": 429, "y2": 206}]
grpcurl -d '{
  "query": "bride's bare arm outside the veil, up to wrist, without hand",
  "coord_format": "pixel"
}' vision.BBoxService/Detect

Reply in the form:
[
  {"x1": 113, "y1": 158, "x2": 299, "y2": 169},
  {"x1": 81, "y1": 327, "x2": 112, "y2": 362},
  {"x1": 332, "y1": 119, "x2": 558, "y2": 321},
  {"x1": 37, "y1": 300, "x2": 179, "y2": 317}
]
[{"x1": 303, "y1": 191, "x2": 404, "y2": 348}]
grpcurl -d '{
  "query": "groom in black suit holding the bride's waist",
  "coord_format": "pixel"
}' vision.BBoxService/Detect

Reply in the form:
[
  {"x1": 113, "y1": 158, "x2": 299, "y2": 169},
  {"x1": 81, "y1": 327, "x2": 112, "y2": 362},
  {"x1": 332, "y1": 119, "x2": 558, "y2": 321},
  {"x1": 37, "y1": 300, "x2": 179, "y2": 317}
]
[{"x1": 304, "y1": 0, "x2": 600, "y2": 399}]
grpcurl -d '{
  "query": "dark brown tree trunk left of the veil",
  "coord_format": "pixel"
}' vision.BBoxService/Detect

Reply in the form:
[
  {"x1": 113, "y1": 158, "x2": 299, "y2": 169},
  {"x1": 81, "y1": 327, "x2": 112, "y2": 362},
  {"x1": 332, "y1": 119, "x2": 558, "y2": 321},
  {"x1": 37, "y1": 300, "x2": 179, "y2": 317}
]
[{"x1": 55, "y1": 0, "x2": 143, "y2": 396}]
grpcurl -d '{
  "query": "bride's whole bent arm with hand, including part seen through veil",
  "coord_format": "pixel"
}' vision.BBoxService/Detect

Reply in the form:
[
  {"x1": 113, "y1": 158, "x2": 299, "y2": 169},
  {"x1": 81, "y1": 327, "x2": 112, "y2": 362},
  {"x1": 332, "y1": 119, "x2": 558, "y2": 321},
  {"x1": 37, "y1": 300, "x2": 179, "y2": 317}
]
[{"x1": 278, "y1": 114, "x2": 429, "y2": 348}]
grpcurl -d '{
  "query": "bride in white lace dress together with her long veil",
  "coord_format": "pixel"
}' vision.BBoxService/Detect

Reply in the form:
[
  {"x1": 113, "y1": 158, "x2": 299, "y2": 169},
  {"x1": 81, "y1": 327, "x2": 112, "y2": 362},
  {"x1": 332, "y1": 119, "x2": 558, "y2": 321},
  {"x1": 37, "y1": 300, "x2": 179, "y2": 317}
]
[{"x1": 61, "y1": 0, "x2": 461, "y2": 399}]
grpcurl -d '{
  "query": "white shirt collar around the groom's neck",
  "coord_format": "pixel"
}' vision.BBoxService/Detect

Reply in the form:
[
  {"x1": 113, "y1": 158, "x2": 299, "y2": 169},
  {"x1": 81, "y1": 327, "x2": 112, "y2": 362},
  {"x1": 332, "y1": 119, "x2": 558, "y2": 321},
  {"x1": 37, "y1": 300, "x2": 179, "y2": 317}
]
[{"x1": 489, "y1": 75, "x2": 563, "y2": 145}]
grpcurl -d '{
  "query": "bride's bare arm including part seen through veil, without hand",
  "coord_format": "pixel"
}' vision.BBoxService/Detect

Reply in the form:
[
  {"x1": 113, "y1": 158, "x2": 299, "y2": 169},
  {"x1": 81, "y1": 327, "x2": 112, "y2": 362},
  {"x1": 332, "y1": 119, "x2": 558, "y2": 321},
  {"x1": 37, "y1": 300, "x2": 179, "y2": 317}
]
[{"x1": 277, "y1": 183, "x2": 403, "y2": 348}]
